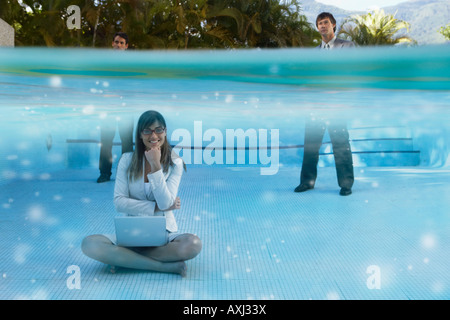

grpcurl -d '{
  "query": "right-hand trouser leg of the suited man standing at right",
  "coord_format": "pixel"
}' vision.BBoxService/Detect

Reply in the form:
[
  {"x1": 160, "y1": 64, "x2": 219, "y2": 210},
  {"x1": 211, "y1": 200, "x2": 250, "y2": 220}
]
[{"x1": 328, "y1": 122, "x2": 354, "y2": 196}]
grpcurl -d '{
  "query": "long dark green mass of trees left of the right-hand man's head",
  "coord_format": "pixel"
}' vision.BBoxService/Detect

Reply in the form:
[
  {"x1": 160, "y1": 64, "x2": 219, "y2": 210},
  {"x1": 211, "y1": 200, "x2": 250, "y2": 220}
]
[{"x1": 0, "y1": 0, "x2": 320, "y2": 49}]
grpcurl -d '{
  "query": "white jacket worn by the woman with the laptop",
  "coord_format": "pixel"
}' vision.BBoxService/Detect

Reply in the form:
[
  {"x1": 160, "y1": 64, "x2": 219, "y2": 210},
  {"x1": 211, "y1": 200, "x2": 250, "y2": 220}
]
[{"x1": 114, "y1": 152, "x2": 183, "y2": 232}]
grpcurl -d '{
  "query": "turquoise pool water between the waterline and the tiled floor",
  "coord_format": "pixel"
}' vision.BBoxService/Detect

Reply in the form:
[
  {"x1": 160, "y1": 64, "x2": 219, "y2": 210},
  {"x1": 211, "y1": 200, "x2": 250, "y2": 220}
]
[{"x1": 0, "y1": 46, "x2": 450, "y2": 181}]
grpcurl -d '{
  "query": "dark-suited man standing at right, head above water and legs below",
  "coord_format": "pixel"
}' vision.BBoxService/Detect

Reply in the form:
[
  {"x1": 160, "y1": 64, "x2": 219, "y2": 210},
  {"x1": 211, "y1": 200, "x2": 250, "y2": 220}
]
[{"x1": 294, "y1": 12, "x2": 355, "y2": 196}]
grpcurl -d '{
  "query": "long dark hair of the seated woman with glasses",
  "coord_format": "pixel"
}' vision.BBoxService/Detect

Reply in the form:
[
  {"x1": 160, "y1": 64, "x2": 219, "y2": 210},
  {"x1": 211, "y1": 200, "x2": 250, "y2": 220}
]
[{"x1": 128, "y1": 110, "x2": 173, "y2": 180}]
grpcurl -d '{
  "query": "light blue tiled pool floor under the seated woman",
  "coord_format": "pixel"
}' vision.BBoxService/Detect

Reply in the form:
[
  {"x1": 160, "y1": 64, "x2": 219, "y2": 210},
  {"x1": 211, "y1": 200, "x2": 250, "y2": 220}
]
[{"x1": 0, "y1": 166, "x2": 450, "y2": 300}]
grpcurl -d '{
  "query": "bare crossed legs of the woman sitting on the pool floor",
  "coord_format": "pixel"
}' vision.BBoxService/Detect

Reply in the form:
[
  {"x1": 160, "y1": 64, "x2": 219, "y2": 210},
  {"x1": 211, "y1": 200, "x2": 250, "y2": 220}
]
[{"x1": 81, "y1": 235, "x2": 201, "y2": 277}]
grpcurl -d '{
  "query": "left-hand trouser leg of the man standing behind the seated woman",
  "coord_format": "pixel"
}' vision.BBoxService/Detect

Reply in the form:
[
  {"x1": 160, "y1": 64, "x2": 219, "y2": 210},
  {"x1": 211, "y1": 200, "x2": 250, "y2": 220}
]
[{"x1": 97, "y1": 117, "x2": 116, "y2": 183}]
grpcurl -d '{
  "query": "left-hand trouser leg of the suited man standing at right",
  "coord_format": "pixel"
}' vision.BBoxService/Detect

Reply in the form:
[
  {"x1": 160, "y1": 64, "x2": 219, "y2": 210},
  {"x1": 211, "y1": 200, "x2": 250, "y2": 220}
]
[{"x1": 294, "y1": 119, "x2": 326, "y2": 192}]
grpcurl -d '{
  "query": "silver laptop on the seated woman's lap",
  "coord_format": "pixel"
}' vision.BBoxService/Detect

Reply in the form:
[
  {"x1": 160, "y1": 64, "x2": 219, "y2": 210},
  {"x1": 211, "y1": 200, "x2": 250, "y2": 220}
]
[{"x1": 114, "y1": 216, "x2": 167, "y2": 247}]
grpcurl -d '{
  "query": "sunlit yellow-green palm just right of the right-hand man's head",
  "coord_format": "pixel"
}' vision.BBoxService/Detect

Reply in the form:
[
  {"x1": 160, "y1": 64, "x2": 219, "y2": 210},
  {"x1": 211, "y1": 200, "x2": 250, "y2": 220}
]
[{"x1": 339, "y1": 10, "x2": 415, "y2": 46}]
